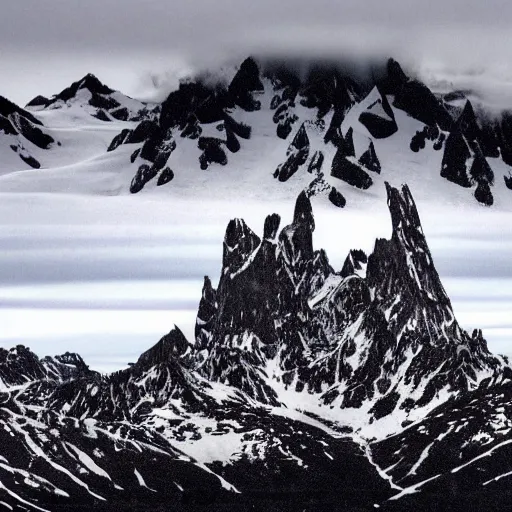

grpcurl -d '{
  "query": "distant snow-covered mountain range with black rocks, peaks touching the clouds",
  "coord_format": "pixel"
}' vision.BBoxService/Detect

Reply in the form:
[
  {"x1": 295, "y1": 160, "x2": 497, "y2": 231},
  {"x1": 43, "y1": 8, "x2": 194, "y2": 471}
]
[{"x1": 0, "y1": 54, "x2": 512, "y2": 209}]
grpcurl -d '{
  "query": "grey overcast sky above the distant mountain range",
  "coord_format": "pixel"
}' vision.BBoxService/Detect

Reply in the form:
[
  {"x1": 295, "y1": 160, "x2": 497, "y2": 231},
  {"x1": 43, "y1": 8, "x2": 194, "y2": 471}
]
[{"x1": 0, "y1": 0, "x2": 512, "y2": 104}]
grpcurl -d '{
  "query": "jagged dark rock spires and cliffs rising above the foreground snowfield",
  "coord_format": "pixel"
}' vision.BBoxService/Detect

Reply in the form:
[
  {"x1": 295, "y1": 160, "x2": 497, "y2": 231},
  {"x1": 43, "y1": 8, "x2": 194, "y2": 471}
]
[{"x1": 191, "y1": 182, "x2": 501, "y2": 420}]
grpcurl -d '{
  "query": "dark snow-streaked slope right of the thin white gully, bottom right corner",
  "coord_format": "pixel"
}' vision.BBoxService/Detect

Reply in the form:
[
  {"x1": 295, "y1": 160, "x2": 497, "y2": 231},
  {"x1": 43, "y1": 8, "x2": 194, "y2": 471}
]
[{"x1": 372, "y1": 369, "x2": 512, "y2": 511}]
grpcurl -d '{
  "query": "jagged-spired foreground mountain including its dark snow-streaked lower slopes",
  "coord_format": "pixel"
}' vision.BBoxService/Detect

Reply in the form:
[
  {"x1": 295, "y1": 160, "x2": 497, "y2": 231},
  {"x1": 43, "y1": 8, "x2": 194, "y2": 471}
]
[{"x1": 0, "y1": 185, "x2": 512, "y2": 511}]
